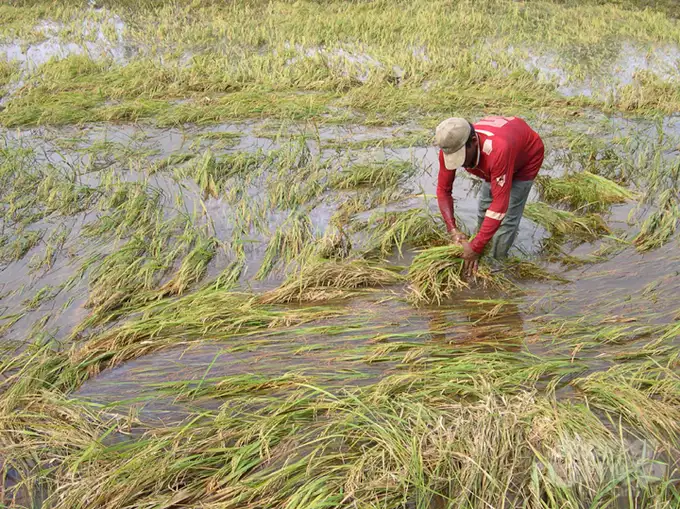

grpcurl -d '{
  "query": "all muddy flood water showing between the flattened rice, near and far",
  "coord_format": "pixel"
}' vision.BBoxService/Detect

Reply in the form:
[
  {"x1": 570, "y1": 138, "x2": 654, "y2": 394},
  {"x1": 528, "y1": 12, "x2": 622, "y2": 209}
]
[{"x1": 0, "y1": 11, "x2": 680, "y2": 498}]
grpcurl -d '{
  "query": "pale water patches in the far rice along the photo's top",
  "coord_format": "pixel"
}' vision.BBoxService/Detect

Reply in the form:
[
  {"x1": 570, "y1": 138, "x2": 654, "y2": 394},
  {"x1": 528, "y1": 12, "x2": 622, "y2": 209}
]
[{"x1": 0, "y1": 9, "x2": 680, "y2": 106}]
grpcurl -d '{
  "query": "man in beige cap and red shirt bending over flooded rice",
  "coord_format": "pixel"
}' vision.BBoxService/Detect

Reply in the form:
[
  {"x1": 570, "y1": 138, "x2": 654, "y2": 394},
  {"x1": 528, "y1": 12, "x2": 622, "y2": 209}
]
[{"x1": 435, "y1": 117, "x2": 544, "y2": 274}]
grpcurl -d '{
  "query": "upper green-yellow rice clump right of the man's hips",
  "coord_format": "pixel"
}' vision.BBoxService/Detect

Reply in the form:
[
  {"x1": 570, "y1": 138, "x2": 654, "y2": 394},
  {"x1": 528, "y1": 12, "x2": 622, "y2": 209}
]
[{"x1": 536, "y1": 171, "x2": 635, "y2": 212}]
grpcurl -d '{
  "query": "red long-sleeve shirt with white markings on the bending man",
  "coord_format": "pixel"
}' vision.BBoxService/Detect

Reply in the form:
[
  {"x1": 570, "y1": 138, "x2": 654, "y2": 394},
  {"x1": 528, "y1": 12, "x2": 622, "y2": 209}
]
[{"x1": 437, "y1": 113, "x2": 544, "y2": 253}]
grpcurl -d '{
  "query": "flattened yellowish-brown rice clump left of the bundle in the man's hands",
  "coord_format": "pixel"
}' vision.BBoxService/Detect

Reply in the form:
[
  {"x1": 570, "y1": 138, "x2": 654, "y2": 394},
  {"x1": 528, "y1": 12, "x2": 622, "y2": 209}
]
[{"x1": 259, "y1": 260, "x2": 402, "y2": 304}]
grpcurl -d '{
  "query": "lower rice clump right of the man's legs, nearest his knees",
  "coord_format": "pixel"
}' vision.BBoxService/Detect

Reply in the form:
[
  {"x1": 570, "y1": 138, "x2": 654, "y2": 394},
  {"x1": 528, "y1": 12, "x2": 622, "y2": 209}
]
[{"x1": 524, "y1": 202, "x2": 611, "y2": 240}]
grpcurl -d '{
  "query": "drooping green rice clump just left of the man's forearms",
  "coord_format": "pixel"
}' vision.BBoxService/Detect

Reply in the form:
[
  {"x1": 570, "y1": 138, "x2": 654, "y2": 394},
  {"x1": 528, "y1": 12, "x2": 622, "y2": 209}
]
[{"x1": 369, "y1": 209, "x2": 449, "y2": 255}]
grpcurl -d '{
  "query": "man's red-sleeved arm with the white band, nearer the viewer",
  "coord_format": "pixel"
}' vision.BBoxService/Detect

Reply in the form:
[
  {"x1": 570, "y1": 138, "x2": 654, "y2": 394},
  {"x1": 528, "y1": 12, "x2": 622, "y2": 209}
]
[{"x1": 470, "y1": 145, "x2": 515, "y2": 254}]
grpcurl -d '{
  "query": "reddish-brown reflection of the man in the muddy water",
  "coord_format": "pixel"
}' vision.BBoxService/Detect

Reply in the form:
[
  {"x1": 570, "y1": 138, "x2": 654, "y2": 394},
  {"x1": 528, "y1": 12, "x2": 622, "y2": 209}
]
[{"x1": 429, "y1": 300, "x2": 524, "y2": 351}]
